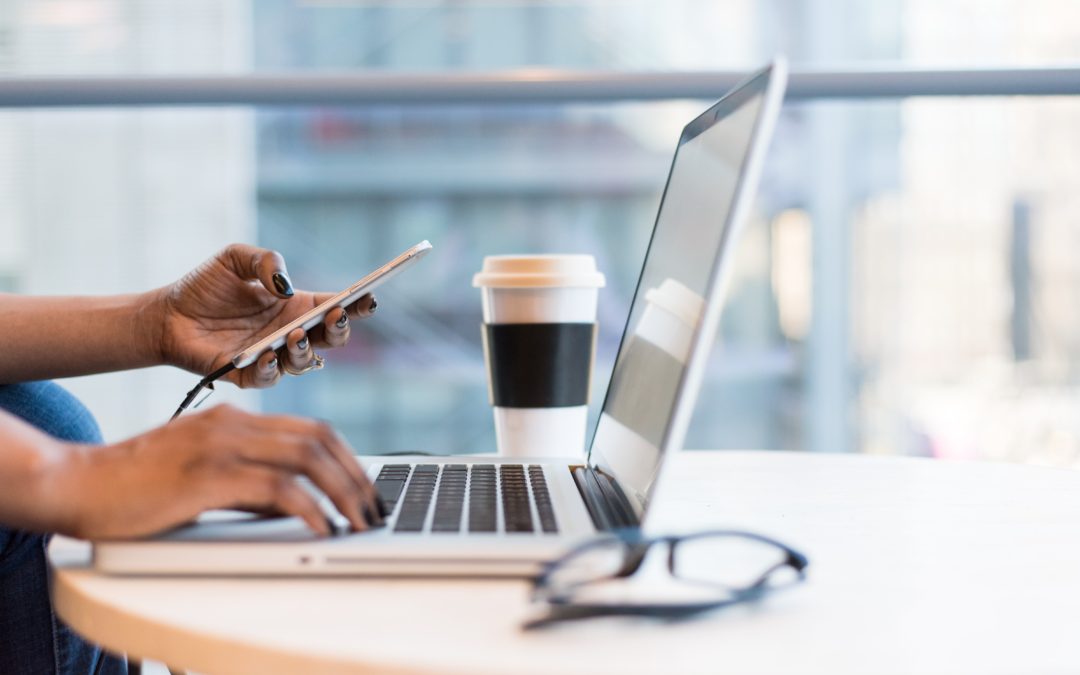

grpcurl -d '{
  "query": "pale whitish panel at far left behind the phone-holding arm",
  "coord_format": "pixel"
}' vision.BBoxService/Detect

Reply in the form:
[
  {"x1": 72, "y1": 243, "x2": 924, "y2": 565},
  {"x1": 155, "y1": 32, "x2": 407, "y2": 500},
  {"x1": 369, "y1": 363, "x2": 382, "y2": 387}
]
[{"x1": 0, "y1": 109, "x2": 258, "y2": 441}]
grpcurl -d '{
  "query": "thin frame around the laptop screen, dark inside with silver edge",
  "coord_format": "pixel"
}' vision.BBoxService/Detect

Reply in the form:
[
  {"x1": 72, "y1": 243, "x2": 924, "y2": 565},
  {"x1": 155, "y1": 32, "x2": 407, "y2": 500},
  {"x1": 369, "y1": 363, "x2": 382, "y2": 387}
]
[{"x1": 586, "y1": 57, "x2": 787, "y2": 519}]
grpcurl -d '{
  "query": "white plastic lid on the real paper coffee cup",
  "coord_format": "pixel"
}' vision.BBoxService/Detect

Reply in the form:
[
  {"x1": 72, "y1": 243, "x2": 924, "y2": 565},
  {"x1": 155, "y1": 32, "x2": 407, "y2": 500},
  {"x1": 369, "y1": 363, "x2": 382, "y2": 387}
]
[{"x1": 473, "y1": 254, "x2": 604, "y2": 288}]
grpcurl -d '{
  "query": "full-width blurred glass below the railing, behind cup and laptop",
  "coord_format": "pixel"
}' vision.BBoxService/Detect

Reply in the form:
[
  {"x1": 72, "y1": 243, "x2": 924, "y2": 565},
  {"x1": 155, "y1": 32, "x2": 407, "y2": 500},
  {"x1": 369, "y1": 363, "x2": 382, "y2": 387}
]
[{"x1": 0, "y1": 99, "x2": 1080, "y2": 464}]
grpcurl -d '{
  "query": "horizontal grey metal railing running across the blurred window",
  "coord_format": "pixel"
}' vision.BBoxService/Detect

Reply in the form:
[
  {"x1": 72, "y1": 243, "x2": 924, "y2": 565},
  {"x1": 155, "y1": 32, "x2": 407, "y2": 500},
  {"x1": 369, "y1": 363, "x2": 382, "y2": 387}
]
[{"x1": 0, "y1": 67, "x2": 1080, "y2": 107}]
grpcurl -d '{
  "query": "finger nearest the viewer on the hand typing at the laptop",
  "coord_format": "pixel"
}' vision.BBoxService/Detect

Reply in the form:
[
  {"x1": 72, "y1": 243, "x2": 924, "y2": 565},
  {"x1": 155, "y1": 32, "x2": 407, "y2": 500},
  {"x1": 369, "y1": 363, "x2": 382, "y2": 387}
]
[{"x1": 218, "y1": 463, "x2": 324, "y2": 537}]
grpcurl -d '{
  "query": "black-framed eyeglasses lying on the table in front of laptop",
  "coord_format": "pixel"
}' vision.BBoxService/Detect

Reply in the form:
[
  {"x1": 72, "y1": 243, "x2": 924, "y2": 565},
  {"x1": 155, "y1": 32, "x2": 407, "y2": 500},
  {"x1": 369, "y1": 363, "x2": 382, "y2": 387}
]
[{"x1": 524, "y1": 530, "x2": 809, "y2": 630}]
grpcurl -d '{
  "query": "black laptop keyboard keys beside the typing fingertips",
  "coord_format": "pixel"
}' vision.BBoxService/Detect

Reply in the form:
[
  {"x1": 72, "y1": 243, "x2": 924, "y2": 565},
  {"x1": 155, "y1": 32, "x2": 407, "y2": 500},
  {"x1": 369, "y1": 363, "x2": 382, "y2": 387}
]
[{"x1": 375, "y1": 464, "x2": 558, "y2": 534}]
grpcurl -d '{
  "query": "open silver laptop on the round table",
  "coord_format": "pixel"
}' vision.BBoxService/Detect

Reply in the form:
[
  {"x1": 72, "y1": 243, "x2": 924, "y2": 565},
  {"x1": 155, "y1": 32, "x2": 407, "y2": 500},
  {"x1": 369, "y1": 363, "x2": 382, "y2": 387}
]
[{"x1": 94, "y1": 59, "x2": 786, "y2": 577}]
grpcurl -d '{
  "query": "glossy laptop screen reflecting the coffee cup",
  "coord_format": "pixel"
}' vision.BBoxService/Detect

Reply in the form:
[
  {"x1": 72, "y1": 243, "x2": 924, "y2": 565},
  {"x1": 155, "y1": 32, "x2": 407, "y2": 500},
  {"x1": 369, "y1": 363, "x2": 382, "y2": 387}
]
[{"x1": 589, "y1": 64, "x2": 774, "y2": 516}]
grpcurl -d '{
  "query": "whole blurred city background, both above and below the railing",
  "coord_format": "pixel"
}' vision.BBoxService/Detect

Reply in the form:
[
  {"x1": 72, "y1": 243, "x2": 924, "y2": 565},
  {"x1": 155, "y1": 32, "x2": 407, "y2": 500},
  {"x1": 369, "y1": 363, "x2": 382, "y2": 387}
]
[{"x1": 0, "y1": 0, "x2": 1080, "y2": 465}]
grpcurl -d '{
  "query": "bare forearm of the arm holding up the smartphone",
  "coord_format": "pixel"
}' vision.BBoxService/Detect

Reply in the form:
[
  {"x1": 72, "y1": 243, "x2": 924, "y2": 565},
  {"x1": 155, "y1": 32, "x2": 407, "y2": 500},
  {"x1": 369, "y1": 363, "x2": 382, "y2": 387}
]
[{"x1": 0, "y1": 292, "x2": 162, "y2": 383}]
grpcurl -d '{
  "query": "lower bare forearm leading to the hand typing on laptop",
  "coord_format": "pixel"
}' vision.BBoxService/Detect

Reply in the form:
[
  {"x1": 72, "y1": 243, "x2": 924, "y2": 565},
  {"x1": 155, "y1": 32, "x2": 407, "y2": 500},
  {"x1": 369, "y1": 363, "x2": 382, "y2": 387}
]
[{"x1": 0, "y1": 410, "x2": 80, "y2": 535}]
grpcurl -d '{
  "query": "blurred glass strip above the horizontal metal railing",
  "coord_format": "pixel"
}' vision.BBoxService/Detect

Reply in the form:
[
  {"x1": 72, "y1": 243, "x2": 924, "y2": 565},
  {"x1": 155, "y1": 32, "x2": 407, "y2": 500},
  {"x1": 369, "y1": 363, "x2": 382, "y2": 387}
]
[{"x1": 0, "y1": 0, "x2": 1080, "y2": 75}]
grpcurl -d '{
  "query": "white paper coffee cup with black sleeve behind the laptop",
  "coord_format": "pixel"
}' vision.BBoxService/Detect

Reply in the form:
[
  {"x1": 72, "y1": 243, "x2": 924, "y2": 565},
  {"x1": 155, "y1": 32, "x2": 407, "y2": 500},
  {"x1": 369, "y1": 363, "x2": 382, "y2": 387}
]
[{"x1": 473, "y1": 255, "x2": 604, "y2": 457}]
